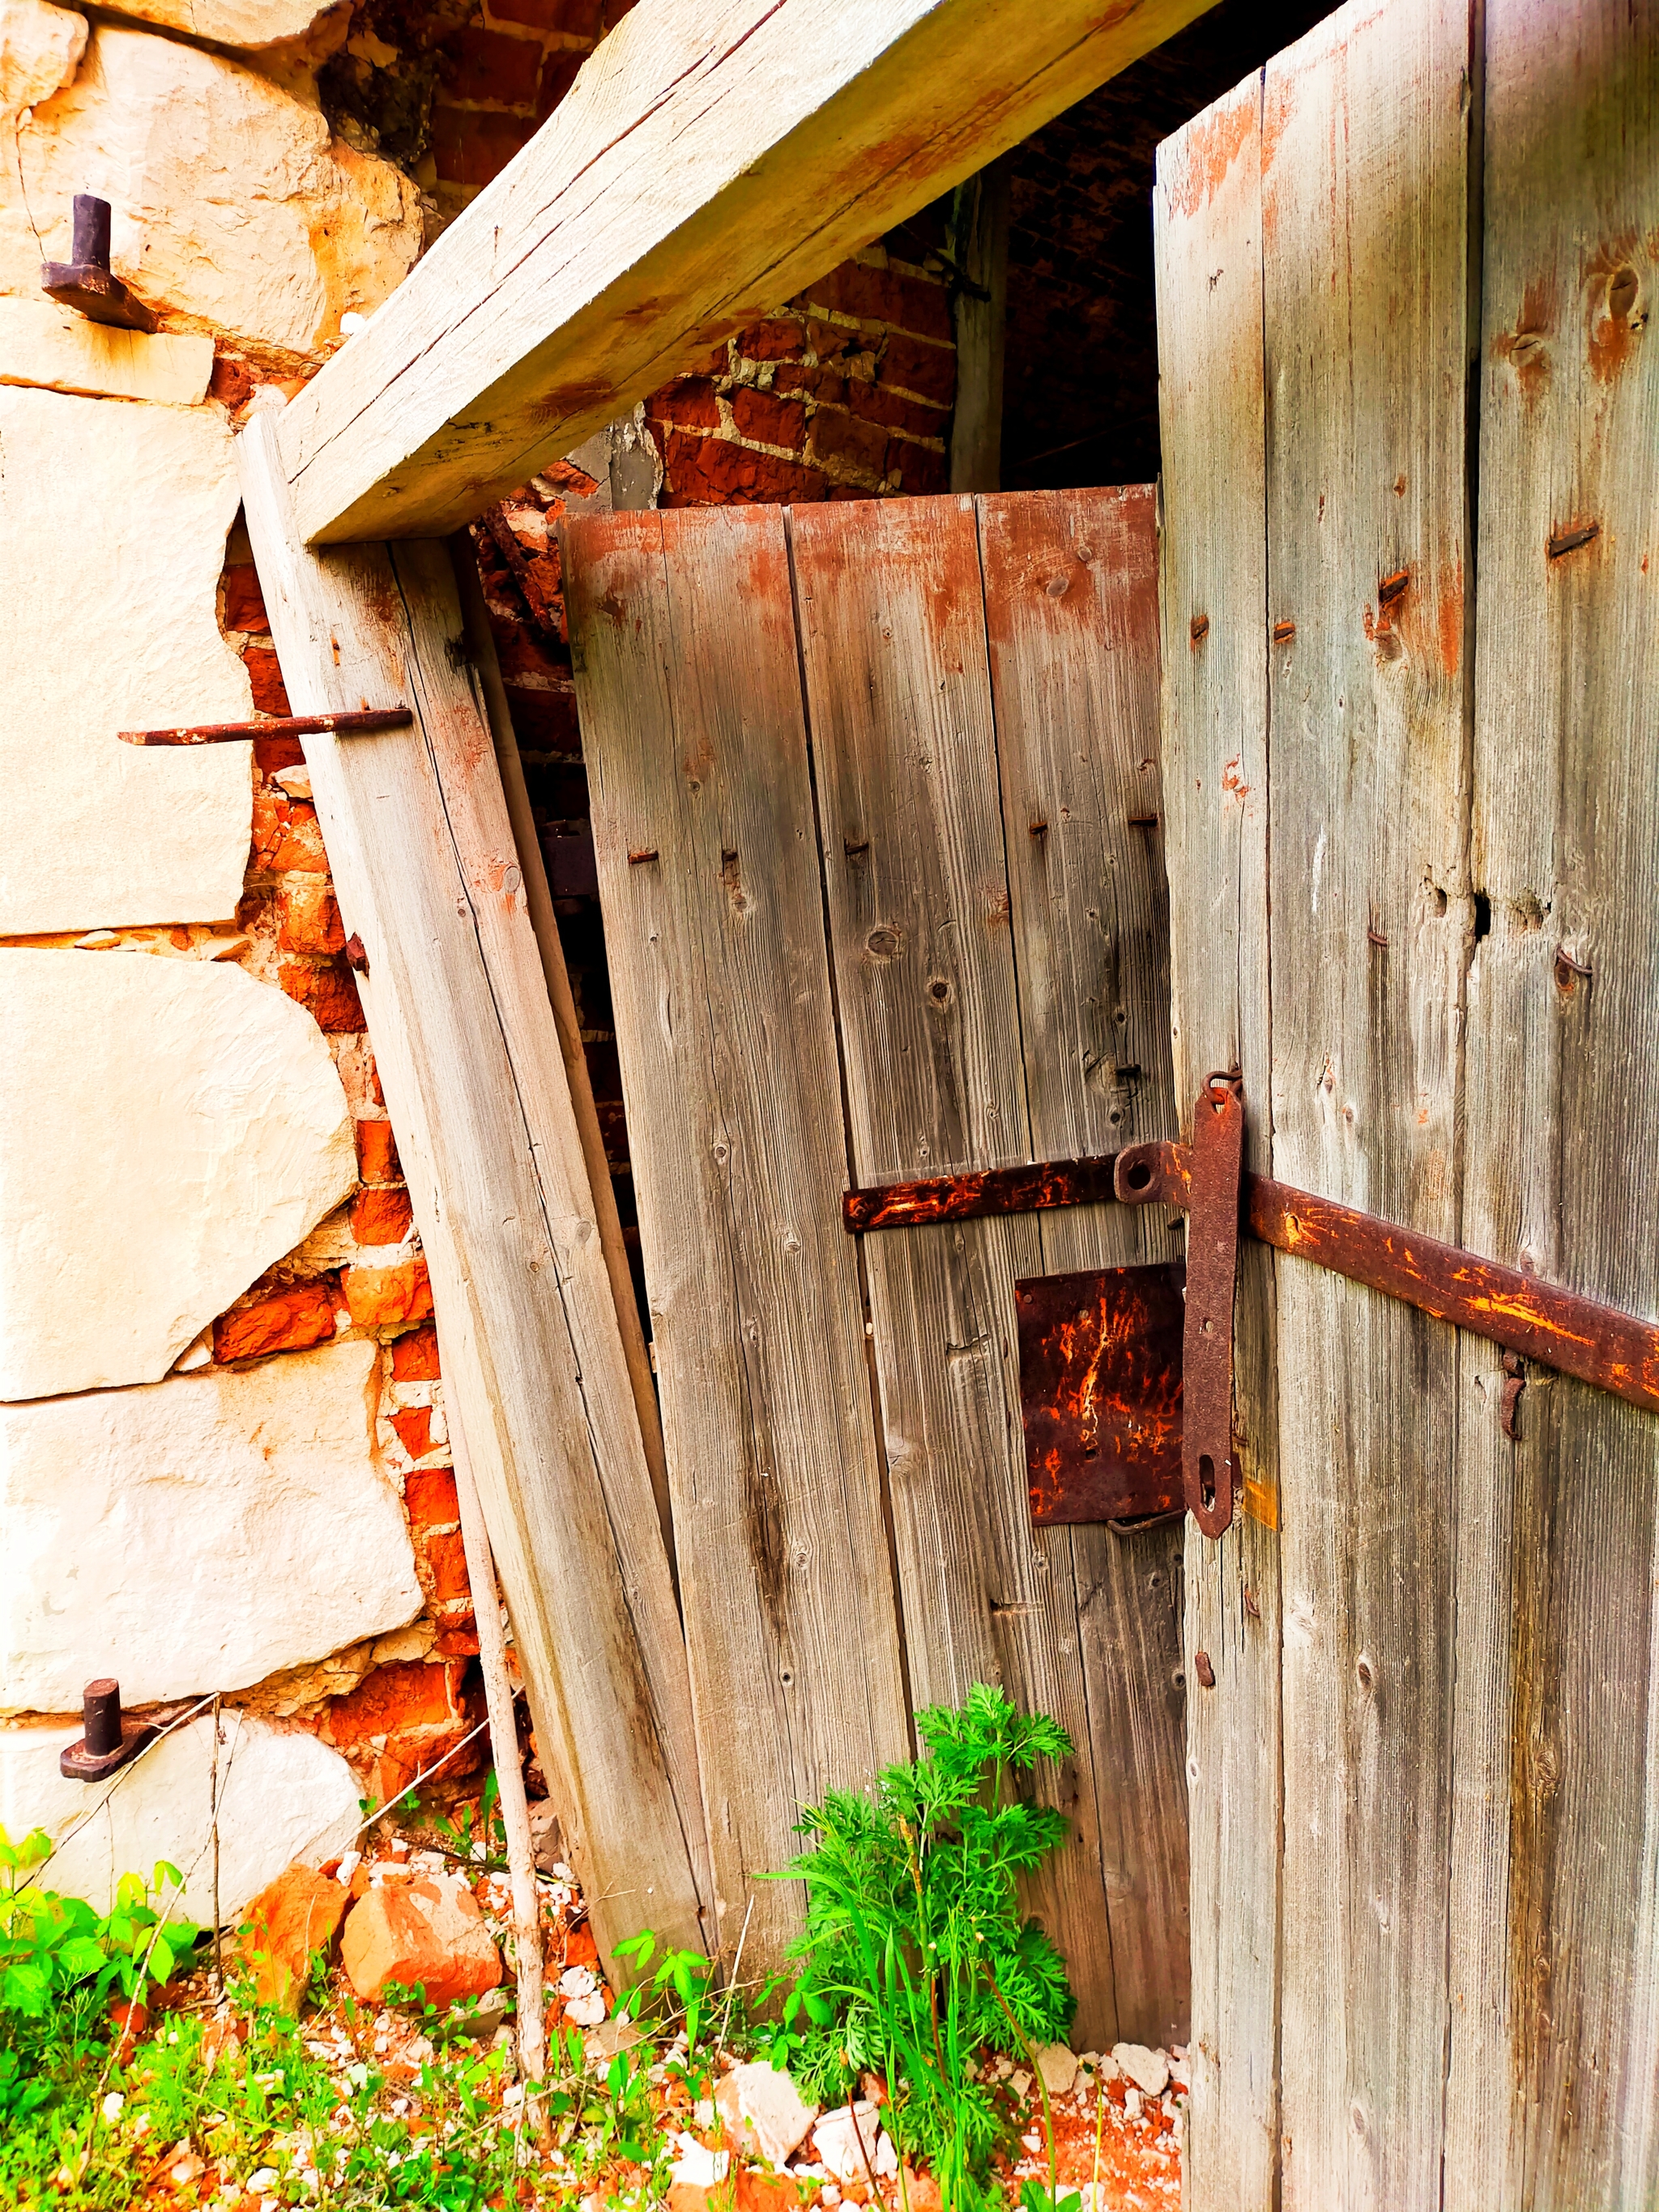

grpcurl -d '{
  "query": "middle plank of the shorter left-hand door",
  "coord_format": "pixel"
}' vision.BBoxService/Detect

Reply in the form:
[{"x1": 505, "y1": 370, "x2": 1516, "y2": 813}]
[{"x1": 792, "y1": 497, "x2": 1117, "y2": 2046}]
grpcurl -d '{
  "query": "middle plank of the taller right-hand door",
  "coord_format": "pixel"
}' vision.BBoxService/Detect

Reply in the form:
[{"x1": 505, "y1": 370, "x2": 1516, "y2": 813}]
[{"x1": 1245, "y1": 0, "x2": 1473, "y2": 2212}]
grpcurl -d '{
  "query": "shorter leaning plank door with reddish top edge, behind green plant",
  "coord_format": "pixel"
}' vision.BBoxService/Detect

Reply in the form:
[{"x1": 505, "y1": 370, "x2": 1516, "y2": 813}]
[{"x1": 566, "y1": 487, "x2": 1188, "y2": 2046}]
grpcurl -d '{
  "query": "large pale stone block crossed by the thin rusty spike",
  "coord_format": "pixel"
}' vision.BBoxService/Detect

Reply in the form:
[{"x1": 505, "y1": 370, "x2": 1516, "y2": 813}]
[{"x1": 0, "y1": 387, "x2": 252, "y2": 938}]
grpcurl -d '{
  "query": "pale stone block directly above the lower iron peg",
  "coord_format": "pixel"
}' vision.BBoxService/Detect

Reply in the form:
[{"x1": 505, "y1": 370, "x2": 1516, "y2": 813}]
[{"x1": 0, "y1": 1340, "x2": 420, "y2": 1712}]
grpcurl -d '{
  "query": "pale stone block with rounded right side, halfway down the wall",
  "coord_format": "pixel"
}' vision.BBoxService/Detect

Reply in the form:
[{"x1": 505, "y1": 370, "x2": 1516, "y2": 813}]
[{"x1": 0, "y1": 947, "x2": 356, "y2": 1397}]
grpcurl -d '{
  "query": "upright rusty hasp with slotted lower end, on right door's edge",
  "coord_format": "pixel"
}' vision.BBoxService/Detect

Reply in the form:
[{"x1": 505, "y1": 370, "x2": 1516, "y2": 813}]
[{"x1": 1181, "y1": 1075, "x2": 1243, "y2": 1537}]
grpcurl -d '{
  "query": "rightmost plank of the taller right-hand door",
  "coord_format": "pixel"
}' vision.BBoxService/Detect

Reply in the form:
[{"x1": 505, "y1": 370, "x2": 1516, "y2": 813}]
[{"x1": 1444, "y1": 0, "x2": 1659, "y2": 2212}]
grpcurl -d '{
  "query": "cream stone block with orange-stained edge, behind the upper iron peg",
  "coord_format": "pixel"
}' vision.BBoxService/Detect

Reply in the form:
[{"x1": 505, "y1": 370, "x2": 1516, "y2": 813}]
[{"x1": 0, "y1": 24, "x2": 423, "y2": 369}]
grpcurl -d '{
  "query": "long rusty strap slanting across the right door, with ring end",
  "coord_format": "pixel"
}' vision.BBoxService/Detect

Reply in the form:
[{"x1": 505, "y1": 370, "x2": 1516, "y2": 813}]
[{"x1": 1117, "y1": 1144, "x2": 1659, "y2": 1413}]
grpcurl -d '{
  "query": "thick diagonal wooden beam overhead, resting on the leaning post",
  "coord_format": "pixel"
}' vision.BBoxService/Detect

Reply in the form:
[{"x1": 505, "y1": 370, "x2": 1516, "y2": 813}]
[{"x1": 279, "y1": 0, "x2": 1208, "y2": 542}]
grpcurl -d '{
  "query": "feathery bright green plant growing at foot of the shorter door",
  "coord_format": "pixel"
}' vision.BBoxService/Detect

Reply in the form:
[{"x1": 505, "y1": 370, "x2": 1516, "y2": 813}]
[{"x1": 768, "y1": 1683, "x2": 1075, "y2": 2208}]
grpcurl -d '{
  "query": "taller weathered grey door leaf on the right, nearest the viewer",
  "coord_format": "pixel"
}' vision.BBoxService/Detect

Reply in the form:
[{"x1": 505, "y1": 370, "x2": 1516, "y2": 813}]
[{"x1": 1157, "y1": 0, "x2": 1659, "y2": 2212}]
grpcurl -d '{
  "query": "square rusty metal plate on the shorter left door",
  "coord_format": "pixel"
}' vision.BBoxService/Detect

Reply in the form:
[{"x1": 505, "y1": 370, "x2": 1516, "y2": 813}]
[{"x1": 1013, "y1": 1261, "x2": 1186, "y2": 1524}]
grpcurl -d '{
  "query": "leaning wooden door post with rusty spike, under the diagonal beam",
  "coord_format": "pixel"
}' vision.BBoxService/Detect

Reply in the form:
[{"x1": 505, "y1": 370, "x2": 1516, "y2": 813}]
[{"x1": 237, "y1": 416, "x2": 708, "y2": 1949}]
